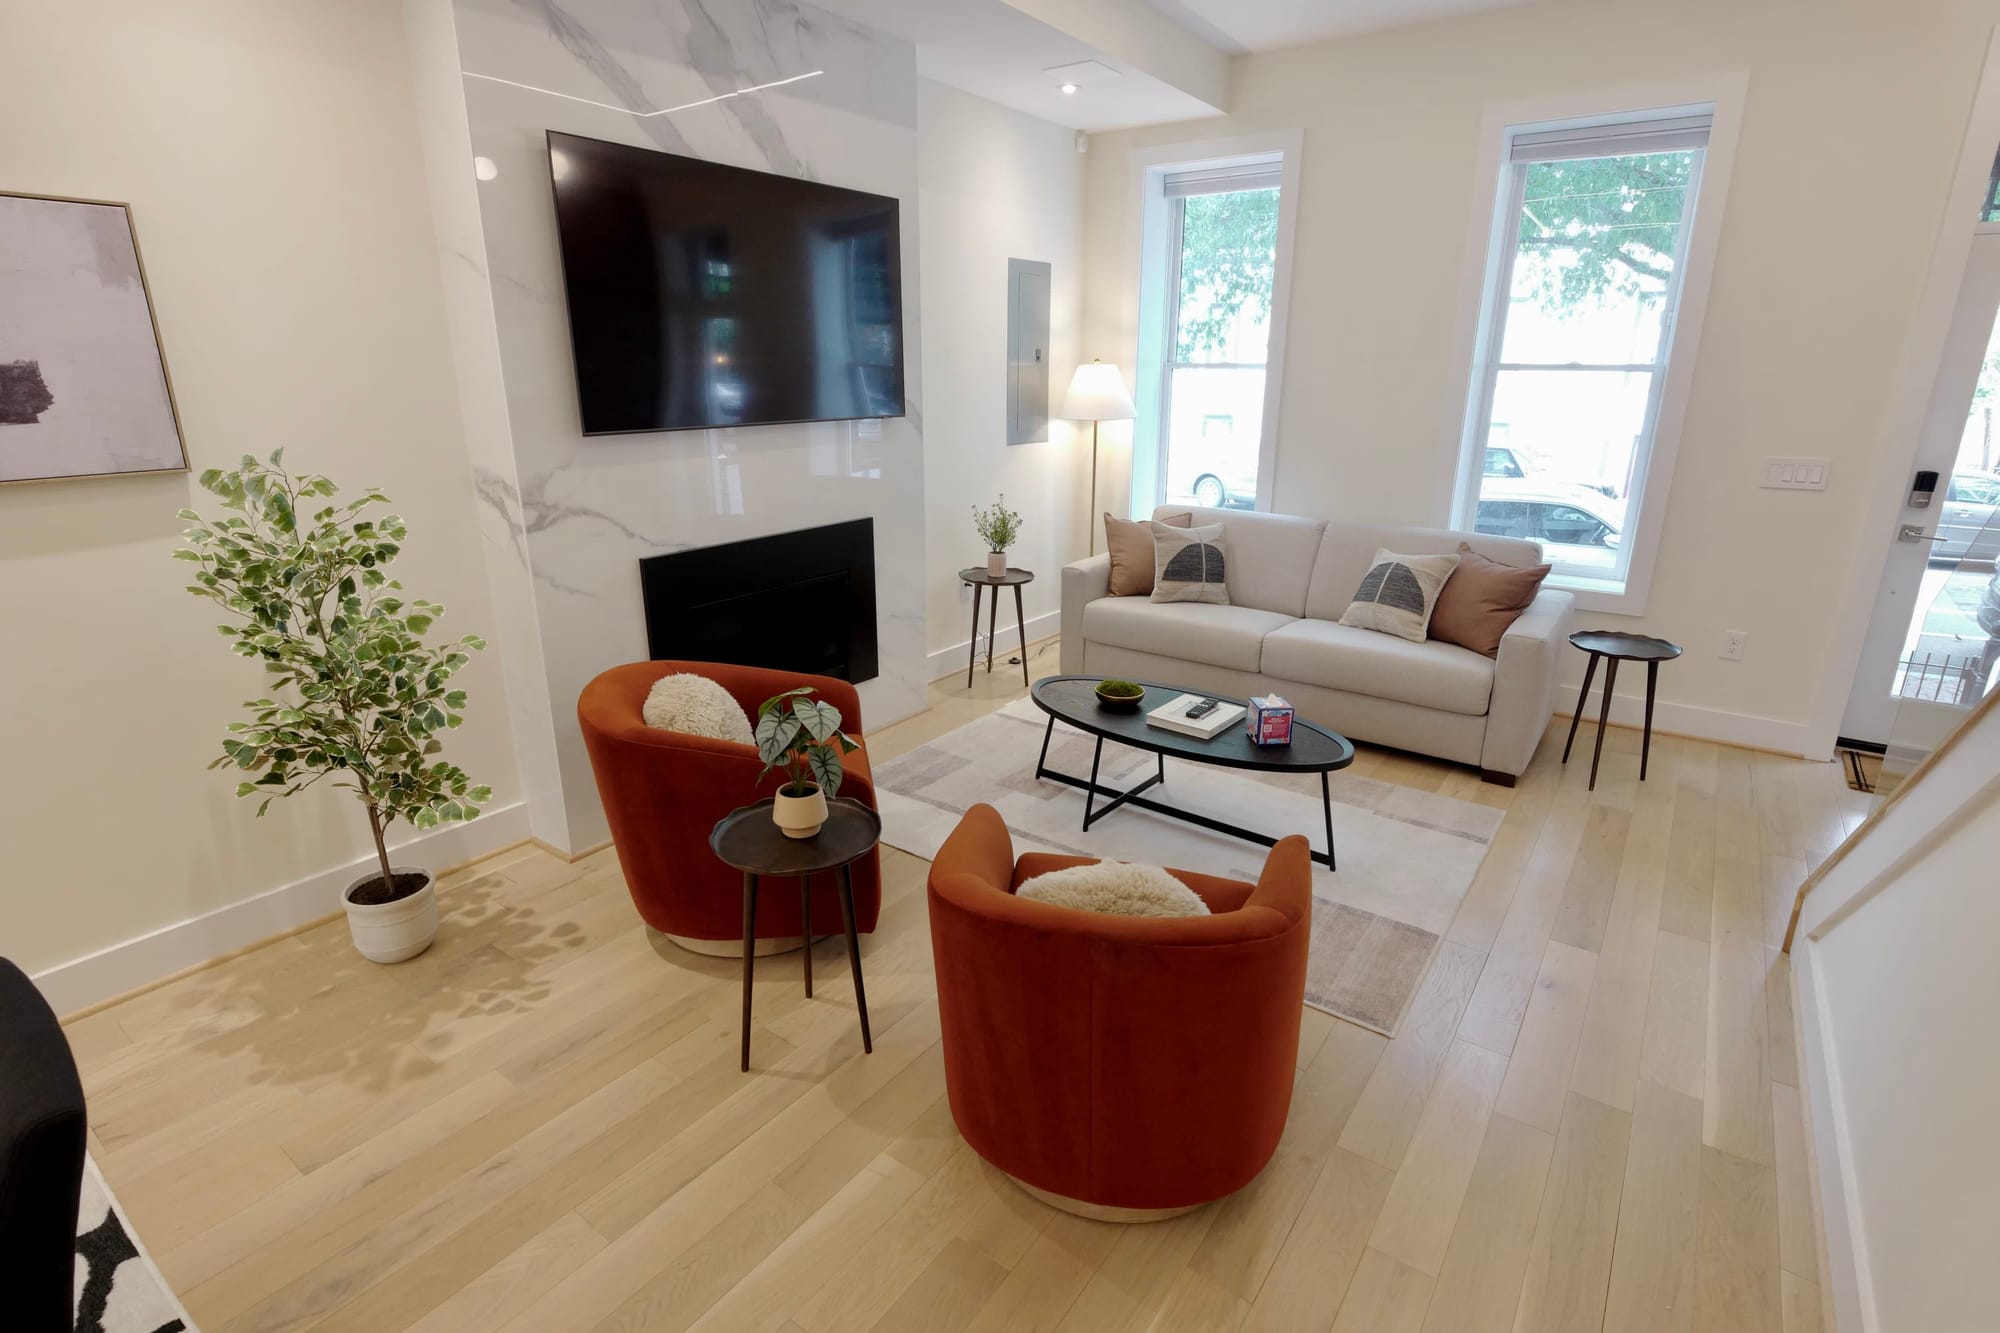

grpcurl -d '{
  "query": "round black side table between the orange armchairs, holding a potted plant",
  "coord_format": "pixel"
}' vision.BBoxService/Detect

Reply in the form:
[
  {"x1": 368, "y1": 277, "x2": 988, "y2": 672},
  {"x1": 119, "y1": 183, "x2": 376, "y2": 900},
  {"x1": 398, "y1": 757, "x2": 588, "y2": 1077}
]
[{"x1": 708, "y1": 797, "x2": 882, "y2": 1073}]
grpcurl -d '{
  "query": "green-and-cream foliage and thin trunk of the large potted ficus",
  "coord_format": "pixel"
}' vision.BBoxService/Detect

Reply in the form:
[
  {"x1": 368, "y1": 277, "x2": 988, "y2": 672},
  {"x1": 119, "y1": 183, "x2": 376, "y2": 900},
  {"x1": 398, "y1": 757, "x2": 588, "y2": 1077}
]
[{"x1": 174, "y1": 448, "x2": 492, "y2": 889}]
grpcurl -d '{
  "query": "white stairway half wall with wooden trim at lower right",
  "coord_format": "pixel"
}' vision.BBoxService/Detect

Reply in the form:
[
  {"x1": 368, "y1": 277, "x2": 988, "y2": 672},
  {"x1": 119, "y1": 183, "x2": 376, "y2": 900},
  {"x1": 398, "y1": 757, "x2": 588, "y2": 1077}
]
[{"x1": 1792, "y1": 701, "x2": 2000, "y2": 1333}]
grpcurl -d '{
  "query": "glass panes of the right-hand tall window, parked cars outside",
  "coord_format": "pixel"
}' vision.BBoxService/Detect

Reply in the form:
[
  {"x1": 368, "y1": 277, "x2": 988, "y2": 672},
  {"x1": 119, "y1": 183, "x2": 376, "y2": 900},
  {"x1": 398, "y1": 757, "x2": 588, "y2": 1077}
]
[{"x1": 1458, "y1": 116, "x2": 1708, "y2": 592}]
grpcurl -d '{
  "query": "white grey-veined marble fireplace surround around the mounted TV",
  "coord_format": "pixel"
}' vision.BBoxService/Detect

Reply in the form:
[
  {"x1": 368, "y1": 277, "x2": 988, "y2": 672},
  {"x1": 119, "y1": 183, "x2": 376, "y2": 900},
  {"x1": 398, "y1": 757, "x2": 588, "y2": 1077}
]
[{"x1": 436, "y1": 0, "x2": 928, "y2": 853}]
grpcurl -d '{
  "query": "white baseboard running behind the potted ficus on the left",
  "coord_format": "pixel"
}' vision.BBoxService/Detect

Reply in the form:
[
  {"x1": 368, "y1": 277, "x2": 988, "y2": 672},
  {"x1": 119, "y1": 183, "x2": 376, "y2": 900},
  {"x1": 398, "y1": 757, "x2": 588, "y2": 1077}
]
[{"x1": 34, "y1": 803, "x2": 528, "y2": 1015}]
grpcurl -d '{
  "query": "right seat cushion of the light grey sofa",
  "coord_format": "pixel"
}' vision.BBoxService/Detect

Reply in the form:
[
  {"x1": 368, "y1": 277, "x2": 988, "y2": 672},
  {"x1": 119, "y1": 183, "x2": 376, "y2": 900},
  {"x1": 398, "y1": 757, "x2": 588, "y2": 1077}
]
[{"x1": 1262, "y1": 620, "x2": 1494, "y2": 717}]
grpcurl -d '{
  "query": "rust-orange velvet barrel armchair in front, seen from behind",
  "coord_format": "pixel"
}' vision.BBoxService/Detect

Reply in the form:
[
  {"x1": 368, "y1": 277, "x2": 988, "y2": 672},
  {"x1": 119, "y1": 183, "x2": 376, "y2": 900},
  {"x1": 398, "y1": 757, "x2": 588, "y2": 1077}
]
[{"x1": 930, "y1": 805, "x2": 1312, "y2": 1221}]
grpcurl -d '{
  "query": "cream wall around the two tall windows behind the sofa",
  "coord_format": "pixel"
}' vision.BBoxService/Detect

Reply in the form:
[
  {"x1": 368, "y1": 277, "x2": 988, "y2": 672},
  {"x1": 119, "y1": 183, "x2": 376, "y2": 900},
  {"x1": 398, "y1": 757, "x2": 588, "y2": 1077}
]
[{"x1": 1084, "y1": 0, "x2": 2000, "y2": 751}]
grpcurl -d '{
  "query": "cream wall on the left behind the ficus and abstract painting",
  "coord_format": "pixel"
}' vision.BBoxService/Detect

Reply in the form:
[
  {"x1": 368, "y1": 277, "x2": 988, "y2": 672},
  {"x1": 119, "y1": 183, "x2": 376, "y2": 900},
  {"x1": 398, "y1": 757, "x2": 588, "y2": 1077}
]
[{"x1": 0, "y1": 0, "x2": 518, "y2": 992}]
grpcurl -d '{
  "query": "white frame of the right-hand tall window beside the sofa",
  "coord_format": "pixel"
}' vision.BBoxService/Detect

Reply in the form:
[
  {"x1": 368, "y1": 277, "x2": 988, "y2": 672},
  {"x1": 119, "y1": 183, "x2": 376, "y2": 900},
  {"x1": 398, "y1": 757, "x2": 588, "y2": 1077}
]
[{"x1": 1448, "y1": 72, "x2": 1748, "y2": 616}]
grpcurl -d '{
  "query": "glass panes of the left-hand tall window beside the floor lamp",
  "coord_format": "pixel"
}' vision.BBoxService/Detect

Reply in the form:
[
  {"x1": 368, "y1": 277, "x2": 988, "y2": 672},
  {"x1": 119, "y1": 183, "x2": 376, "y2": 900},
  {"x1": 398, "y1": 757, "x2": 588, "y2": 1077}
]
[{"x1": 1158, "y1": 162, "x2": 1280, "y2": 508}]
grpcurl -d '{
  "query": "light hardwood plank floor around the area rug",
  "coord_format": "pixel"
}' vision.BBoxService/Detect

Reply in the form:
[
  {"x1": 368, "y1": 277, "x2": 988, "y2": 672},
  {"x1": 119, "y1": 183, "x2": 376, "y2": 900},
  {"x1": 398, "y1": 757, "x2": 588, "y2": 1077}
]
[{"x1": 68, "y1": 644, "x2": 1864, "y2": 1333}]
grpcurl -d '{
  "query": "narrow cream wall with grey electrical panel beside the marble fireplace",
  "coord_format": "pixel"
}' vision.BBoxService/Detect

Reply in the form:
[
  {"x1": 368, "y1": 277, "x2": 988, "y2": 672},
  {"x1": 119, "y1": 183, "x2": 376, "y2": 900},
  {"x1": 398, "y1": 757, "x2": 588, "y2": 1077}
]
[{"x1": 916, "y1": 80, "x2": 1088, "y2": 675}]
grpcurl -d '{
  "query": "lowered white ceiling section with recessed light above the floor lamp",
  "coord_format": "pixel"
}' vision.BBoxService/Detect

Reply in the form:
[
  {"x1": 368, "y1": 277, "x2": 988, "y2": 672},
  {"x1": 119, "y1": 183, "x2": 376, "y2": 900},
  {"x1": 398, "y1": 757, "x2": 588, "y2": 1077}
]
[{"x1": 814, "y1": 0, "x2": 1216, "y2": 130}]
